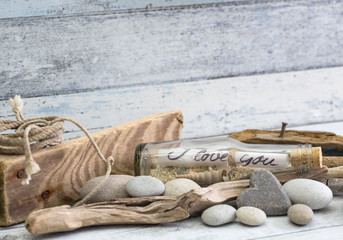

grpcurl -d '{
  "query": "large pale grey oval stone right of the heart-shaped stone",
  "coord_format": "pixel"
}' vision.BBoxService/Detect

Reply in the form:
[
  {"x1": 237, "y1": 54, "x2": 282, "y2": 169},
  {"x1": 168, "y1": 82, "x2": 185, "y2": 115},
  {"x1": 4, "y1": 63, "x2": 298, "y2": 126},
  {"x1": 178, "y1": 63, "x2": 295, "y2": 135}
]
[{"x1": 283, "y1": 178, "x2": 333, "y2": 210}]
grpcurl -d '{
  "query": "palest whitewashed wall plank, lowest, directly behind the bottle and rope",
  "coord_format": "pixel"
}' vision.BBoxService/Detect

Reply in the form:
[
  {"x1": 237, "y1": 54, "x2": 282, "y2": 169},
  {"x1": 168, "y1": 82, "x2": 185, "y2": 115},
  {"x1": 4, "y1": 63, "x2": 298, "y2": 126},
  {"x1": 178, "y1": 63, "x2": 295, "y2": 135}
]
[{"x1": 0, "y1": 67, "x2": 343, "y2": 139}]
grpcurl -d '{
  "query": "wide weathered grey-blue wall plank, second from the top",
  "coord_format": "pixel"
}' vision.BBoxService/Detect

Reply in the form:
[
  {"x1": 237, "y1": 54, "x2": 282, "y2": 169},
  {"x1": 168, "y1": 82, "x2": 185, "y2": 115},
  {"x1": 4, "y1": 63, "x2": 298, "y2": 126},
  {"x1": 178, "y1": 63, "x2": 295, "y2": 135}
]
[{"x1": 0, "y1": 0, "x2": 343, "y2": 100}]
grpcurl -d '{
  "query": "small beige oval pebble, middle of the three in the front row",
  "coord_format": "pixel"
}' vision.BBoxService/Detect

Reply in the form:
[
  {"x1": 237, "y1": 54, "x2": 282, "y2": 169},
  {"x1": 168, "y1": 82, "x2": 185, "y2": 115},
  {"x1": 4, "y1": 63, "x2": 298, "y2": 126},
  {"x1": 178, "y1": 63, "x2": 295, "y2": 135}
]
[{"x1": 236, "y1": 207, "x2": 267, "y2": 226}]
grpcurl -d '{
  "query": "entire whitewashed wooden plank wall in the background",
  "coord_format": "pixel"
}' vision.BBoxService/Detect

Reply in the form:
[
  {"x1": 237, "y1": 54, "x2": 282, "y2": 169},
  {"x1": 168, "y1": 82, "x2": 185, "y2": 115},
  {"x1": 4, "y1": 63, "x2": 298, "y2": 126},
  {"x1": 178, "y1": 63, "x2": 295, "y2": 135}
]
[{"x1": 0, "y1": 0, "x2": 343, "y2": 139}]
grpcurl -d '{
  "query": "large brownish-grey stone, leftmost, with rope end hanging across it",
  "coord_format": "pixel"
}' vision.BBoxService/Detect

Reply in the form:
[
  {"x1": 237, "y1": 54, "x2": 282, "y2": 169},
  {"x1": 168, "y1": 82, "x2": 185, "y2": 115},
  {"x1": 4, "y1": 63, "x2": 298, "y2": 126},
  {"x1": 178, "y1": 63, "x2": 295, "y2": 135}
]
[{"x1": 80, "y1": 175, "x2": 133, "y2": 203}]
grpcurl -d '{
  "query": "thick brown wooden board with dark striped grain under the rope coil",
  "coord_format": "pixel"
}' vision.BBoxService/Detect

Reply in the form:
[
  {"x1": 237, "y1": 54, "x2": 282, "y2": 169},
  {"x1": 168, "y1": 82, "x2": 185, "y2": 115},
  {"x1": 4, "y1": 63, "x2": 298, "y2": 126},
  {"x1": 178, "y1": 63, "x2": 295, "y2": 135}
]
[{"x1": 0, "y1": 111, "x2": 183, "y2": 226}]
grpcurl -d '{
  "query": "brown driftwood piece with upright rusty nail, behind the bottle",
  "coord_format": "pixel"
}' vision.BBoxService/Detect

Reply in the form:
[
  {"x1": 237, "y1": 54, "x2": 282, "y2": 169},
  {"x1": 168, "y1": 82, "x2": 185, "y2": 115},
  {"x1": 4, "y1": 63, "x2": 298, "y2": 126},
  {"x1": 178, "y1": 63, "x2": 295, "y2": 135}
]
[{"x1": 230, "y1": 129, "x2": 343, "y2": 157}]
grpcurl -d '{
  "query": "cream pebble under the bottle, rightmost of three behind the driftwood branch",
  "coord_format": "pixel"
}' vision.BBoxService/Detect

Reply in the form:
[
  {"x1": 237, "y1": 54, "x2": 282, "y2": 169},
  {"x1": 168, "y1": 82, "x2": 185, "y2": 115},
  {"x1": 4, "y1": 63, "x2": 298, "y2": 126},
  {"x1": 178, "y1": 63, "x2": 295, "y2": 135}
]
[{"x1": 163, "y1": 178, "x2": 201, "y2": 196}]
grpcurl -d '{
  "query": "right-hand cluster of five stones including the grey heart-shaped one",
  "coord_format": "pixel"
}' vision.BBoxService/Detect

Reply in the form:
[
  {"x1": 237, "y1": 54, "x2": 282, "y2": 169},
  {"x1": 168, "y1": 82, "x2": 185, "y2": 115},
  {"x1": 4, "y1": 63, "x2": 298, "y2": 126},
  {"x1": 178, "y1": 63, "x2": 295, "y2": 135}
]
[{"x1": 202, "y1": 170, "x2": 333, "y2": 226}]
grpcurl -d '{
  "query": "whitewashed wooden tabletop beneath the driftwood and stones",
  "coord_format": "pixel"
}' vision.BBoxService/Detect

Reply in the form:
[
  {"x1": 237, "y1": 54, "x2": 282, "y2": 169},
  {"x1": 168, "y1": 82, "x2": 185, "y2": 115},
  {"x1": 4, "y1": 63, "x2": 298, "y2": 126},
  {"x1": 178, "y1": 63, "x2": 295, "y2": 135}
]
[{"x1": 0, "y1": 122, "x2": 343, "y2": 240}]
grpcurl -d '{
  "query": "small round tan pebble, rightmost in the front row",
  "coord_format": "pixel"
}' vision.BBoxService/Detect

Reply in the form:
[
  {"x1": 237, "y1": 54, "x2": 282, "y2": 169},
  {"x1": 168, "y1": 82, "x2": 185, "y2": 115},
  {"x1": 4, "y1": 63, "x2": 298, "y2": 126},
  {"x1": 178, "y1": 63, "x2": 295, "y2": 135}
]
[{"x1": 287, "y1": 204, "x2": 313, "y2": 225}]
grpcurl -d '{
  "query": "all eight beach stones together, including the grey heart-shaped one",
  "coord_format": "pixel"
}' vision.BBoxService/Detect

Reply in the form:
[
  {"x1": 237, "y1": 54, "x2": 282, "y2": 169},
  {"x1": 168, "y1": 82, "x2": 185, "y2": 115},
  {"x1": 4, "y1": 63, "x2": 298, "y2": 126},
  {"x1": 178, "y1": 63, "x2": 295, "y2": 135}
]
[{"x1": 81, "y1": 169, "x2": 333, "y2": 226}]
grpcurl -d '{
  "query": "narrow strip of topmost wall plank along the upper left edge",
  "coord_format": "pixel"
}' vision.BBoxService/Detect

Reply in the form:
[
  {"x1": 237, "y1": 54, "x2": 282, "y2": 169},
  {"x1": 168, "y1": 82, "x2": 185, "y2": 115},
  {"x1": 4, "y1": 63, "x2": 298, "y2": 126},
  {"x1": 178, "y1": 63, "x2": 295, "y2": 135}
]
[{"x1": 0, "y1": 0, "x2": 249, "y2": 19}]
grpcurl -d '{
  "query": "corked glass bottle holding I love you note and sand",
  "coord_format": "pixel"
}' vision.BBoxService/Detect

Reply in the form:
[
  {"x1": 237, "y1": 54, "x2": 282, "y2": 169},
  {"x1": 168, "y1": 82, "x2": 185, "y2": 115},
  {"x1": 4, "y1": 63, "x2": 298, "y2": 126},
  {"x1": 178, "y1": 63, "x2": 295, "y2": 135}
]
[{"x1": 134, "y1": 136, "x2": 322, "y2": 186}]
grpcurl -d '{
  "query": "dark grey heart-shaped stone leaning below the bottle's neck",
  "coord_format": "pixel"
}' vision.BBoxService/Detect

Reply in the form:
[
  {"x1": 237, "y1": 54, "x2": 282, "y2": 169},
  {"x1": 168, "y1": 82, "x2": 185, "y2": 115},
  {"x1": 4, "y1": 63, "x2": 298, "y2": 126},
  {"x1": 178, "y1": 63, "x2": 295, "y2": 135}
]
[{"x1": 236, "y1": 169, "x2": 292, "y2": 216}]
